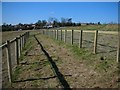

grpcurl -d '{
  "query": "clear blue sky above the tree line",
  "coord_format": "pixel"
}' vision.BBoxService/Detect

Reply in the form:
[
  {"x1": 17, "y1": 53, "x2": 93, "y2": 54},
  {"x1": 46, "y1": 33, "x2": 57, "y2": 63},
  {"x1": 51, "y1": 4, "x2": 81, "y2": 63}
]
[{"x1": 2, "y1": 2, "x2": 118, "y2": 24}]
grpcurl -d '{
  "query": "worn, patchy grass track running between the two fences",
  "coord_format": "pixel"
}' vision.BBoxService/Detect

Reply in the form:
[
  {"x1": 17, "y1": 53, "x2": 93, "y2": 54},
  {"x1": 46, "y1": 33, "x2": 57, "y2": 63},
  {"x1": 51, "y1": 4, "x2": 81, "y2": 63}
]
[{"x1": 12, "y1": 35, "x2": 118, "y2": 88}]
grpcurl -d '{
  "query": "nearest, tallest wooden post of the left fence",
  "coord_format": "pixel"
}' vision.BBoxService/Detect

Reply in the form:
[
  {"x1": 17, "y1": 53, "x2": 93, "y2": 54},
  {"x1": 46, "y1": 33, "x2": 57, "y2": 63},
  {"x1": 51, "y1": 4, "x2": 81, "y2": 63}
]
[{"x1": 6, "y1": 41, "x2": 12, "y2": 83}]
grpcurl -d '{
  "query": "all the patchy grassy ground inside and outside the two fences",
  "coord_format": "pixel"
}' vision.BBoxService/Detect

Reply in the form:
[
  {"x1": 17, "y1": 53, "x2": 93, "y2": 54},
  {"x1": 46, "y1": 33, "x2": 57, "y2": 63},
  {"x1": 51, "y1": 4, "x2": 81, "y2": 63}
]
[{"x1": 2, "y1": 26, "x2": 118, "y2": 88}]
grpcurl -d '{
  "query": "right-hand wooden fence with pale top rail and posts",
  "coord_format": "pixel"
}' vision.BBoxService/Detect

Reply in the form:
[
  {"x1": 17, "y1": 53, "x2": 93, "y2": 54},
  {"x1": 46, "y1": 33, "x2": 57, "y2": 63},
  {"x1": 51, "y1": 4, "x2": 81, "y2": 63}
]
[{"x1": 42, "y1": 29, "x2": 120, "y2": 62}]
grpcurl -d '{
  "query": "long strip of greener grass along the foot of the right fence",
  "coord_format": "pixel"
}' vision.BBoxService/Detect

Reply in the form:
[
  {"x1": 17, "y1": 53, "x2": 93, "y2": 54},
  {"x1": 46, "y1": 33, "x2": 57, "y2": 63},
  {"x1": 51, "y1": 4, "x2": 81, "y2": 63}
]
[{"x1": 45, "y1": 34, "x2": 117, "y2": 72}]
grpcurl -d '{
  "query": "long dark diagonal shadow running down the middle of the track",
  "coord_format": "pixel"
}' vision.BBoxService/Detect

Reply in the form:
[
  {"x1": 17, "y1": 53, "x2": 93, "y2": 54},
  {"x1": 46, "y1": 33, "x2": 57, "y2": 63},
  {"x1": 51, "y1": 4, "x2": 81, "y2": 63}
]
[{"x1": 34, "y1": 36, "x2": 71, "y2": 90}]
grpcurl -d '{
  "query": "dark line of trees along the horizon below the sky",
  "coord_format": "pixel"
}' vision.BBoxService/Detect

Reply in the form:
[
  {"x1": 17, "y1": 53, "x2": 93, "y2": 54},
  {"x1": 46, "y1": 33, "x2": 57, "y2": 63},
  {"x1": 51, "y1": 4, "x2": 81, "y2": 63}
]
[{"x1": 2, "y1": 17, "x2": 100, "y2": 31}]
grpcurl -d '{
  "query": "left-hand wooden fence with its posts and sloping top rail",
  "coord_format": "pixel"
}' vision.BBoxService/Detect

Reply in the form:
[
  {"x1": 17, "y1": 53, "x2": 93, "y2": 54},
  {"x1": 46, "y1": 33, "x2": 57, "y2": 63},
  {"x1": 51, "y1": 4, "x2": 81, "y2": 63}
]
[{"x1": 0, "y1": 32, "x2": 29, "y2": 83}]
